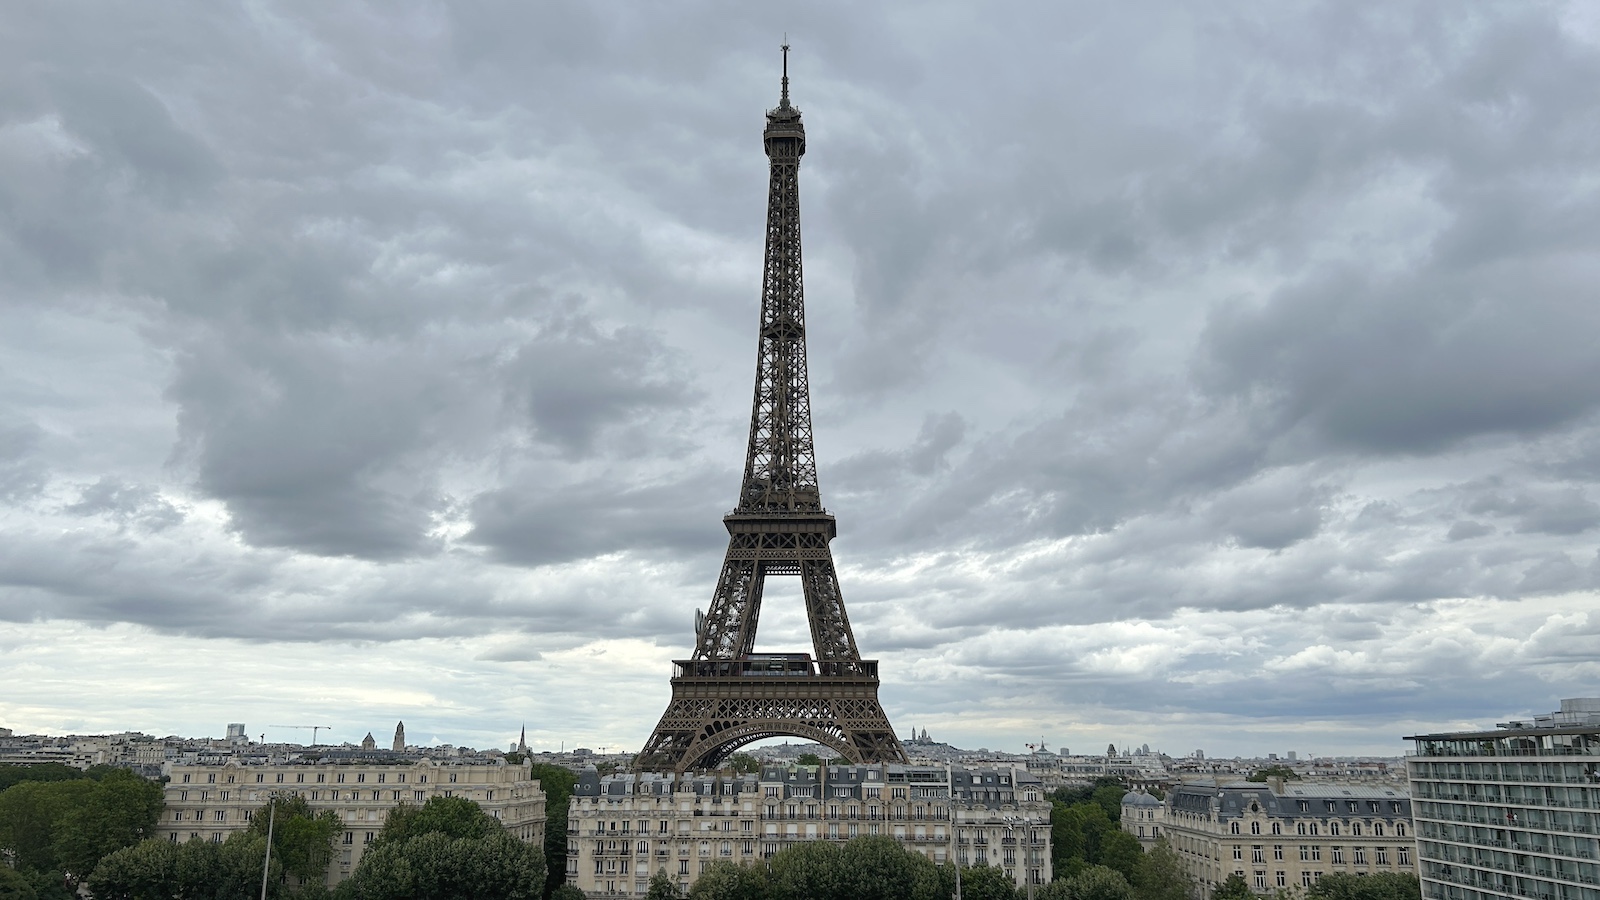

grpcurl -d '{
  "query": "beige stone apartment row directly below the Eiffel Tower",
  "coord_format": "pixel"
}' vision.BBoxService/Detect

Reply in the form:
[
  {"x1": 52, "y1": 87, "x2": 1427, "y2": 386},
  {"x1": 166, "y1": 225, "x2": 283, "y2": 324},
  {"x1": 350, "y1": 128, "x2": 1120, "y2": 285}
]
[{"x1": 566, "y1": 764, "x2": 1051, "y2": 897}]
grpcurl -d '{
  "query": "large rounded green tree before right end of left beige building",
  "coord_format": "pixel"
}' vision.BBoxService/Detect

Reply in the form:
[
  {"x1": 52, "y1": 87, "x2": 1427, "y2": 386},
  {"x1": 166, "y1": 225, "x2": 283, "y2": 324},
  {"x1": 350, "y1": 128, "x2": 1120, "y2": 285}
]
[{"x1": 341, "y1": 798, "x2": 546, "y2": 900}]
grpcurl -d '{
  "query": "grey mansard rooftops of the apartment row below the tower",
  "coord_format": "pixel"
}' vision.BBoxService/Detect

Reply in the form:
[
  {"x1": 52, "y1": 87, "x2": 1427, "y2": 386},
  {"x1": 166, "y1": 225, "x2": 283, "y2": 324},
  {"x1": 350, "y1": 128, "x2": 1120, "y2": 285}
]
[{"x1": 573, "y1": 764, "x2": 1043, "y2": 806}]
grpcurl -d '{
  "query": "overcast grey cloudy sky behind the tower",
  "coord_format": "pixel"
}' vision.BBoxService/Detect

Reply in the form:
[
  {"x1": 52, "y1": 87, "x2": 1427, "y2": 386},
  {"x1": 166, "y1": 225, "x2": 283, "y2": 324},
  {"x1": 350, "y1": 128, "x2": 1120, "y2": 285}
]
[{"x1": 0, "y1": 0, "x2": 1600, "y2": 754}]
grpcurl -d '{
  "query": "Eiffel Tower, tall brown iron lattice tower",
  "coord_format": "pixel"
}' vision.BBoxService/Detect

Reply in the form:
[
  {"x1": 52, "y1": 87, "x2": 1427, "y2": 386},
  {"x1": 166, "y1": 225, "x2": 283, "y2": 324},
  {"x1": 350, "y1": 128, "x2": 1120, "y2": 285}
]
[{"x1": 635, "y1": 43, "x2": 906, "y2": 772}]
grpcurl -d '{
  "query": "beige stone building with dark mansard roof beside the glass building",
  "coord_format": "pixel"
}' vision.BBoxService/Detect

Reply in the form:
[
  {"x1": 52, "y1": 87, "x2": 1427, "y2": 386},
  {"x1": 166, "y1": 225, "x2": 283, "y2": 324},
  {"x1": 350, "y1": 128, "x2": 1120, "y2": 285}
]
[{"x1": 1122, "y1": 778, "x2": 1416, "y2": 897}]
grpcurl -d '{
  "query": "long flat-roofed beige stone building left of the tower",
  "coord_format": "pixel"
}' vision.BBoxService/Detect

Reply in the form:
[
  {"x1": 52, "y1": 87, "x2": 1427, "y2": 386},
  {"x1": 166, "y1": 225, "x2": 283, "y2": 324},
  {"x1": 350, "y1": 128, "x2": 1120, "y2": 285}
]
[{"x1": 155, "y1": 759, "x2": 544, "y2": 886}]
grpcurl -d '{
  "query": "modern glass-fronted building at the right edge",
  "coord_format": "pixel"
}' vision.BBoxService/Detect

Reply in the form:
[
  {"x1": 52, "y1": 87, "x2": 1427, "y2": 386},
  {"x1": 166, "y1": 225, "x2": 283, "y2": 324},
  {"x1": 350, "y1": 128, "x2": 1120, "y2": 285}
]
[{"x1": 1406, "y1": 698, "x2": 1600, "y2": 900}]
